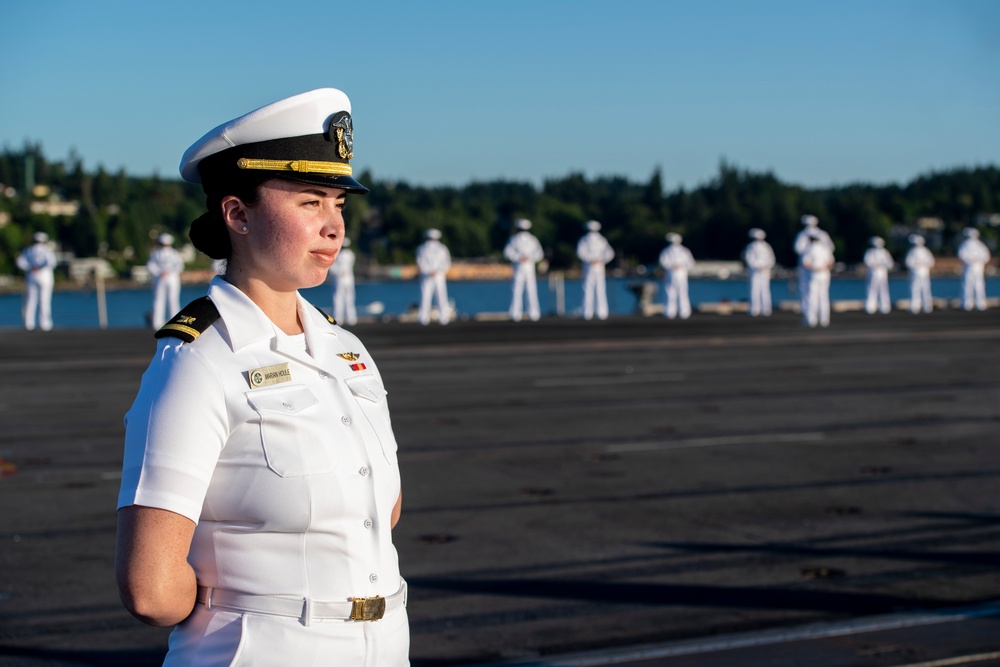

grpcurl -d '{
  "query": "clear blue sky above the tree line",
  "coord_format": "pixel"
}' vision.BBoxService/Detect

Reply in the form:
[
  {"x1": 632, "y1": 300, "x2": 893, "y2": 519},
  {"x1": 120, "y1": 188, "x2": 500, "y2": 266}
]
[{"x1": 0, "y1": 0, "x2": 1000, "y2": 190}]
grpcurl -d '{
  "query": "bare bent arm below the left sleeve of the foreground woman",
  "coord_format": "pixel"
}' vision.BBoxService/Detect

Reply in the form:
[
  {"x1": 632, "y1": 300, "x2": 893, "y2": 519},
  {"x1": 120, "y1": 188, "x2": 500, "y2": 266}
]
[{"x1": 115, "y1": 503, "x2": 198, "y2": 627}]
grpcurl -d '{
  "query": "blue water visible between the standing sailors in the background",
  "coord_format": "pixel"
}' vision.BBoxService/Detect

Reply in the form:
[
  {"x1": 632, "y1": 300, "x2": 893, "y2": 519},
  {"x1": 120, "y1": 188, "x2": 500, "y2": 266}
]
[{"x1": 0, "y1": 277, "x2": 1000, "y2": 329}]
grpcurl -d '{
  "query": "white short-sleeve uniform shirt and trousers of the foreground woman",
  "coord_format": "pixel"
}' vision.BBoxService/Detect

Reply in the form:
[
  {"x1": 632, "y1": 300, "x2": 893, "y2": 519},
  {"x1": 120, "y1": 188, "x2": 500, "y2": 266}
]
[{"x1": 118, "y1": 277, "x2": 409, "y2": 667}]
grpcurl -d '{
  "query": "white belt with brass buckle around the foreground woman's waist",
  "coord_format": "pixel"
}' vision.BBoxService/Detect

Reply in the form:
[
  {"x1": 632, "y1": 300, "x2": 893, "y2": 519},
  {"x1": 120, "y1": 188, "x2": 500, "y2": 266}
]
[{"x1": 197, "y1": 579, "x2": 406, "y2": 626}]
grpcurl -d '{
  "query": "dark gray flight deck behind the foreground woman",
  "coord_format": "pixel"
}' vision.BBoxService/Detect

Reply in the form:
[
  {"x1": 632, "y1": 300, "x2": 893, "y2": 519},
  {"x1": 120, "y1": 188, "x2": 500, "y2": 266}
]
[{"x1": 0, "y1": 309, "x2": 1000, "y2": 667}]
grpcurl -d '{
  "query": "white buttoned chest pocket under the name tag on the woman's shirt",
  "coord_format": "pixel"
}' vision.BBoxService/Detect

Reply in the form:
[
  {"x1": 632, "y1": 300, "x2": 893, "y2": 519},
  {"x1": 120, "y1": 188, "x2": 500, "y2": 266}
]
[{"x1": 246, "y1": 386, "x2": 337, "y2": 477}]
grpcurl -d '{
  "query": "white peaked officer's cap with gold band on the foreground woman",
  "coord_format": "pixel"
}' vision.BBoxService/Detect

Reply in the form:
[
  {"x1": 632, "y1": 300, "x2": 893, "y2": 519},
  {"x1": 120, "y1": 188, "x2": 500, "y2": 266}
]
[{"x1": 180, "y1": 88, "x2": 368, "y2": 194}]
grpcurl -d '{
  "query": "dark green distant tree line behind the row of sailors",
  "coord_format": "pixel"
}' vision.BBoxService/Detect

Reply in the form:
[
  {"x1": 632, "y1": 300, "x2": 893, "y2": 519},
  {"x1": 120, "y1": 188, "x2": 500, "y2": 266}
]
[{"x1": 0, "y1": 144, "x2": 1000, "y2": 275}]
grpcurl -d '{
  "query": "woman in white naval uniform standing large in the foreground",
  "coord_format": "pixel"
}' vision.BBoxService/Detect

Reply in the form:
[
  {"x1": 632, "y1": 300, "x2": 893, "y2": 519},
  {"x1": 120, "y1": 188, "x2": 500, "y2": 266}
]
[{"x1": 116, "y1": 89, "x2": 409, "y2": 667}]
